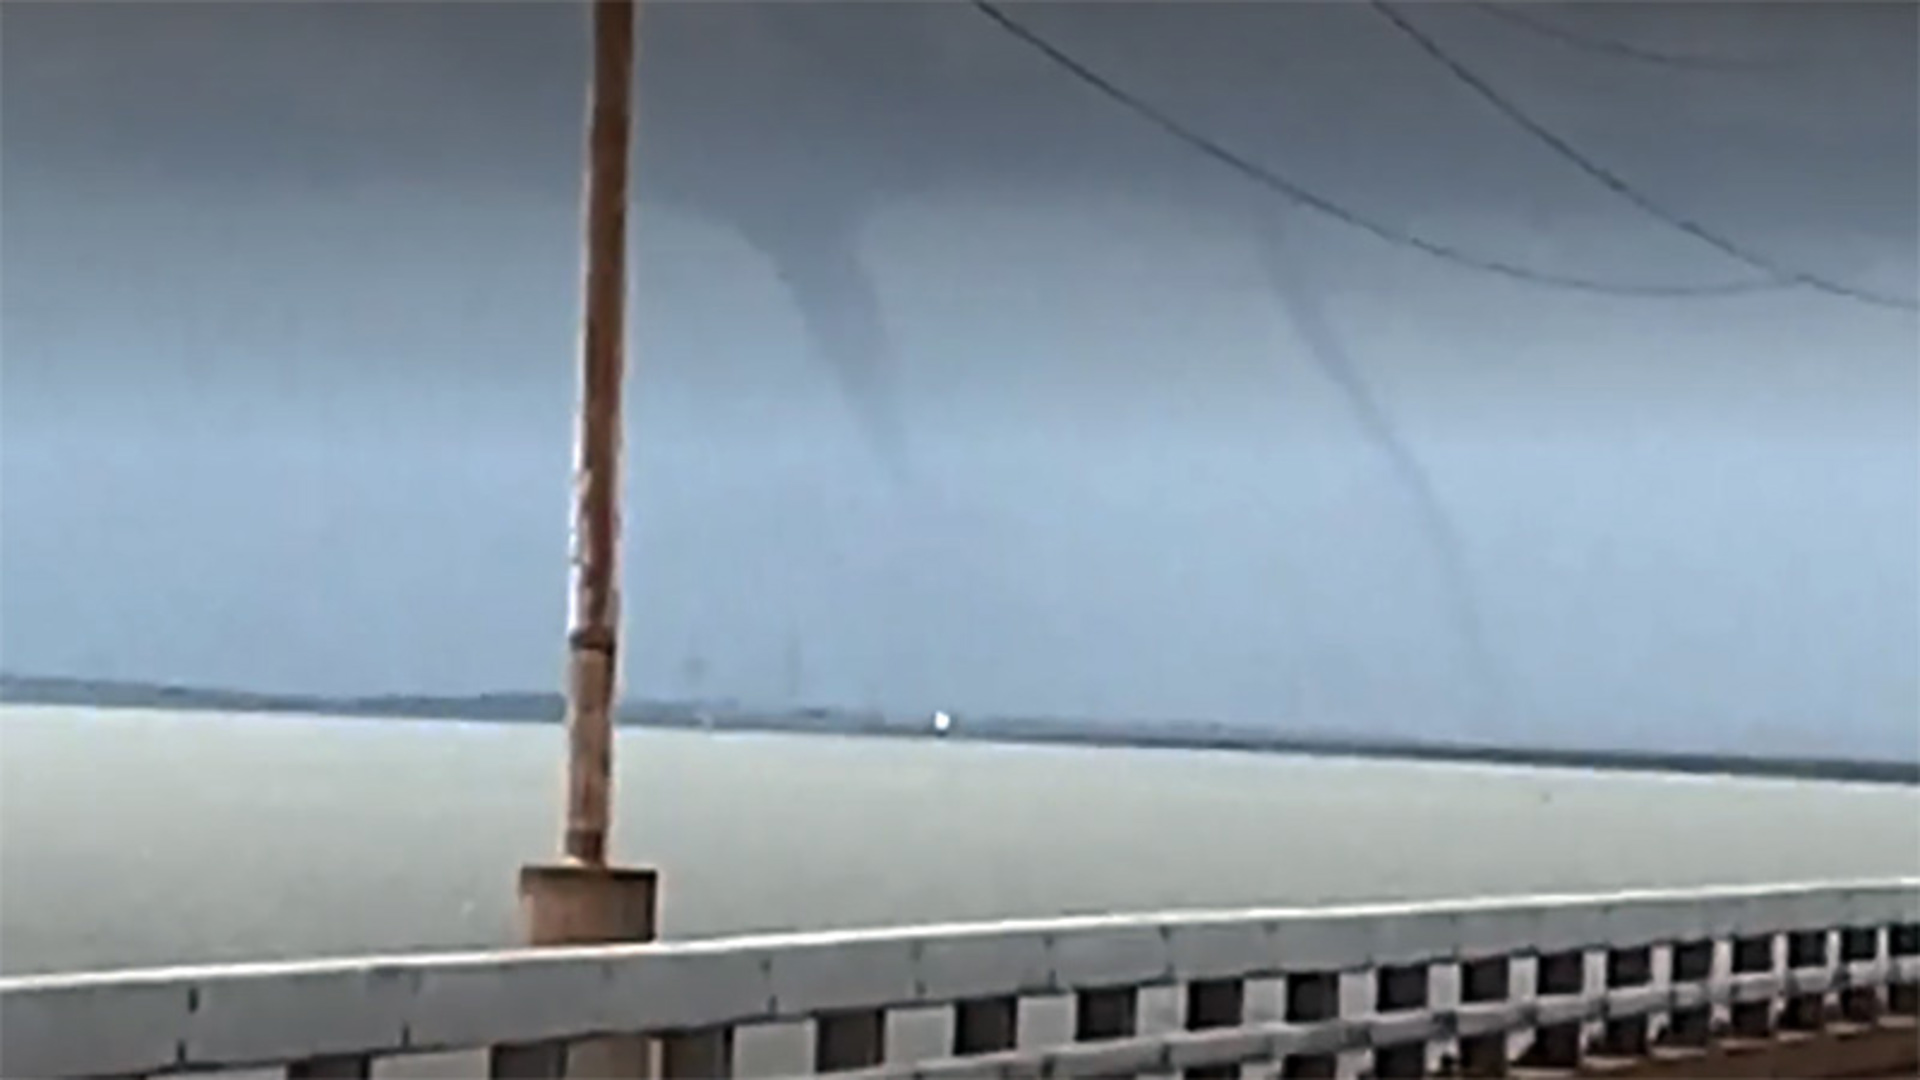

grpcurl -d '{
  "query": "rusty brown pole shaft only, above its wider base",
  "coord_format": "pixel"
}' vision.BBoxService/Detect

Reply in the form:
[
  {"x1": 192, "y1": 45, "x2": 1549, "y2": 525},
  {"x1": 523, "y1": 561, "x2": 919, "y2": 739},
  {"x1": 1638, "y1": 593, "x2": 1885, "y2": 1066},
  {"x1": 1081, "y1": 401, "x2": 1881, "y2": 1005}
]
[{"x1": 564, "y1": 0, "x2": 636, "y2": 867}]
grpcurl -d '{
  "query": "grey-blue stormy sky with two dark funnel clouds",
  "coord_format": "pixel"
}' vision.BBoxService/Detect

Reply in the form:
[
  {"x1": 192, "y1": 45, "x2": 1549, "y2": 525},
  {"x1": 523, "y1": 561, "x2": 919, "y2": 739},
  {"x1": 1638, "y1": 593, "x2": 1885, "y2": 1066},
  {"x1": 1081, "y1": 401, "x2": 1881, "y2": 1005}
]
[{"x1": 0, "y1": 2, "x2": 1920, "y2": 753}]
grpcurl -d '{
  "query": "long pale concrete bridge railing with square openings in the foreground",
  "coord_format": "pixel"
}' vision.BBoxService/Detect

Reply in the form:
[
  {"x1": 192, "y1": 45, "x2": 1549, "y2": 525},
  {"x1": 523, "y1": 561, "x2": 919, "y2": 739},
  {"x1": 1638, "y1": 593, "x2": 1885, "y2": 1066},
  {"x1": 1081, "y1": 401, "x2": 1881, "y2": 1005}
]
[{"x1": 0, "y1": 878, "x2": 1920, "y2": 1078}]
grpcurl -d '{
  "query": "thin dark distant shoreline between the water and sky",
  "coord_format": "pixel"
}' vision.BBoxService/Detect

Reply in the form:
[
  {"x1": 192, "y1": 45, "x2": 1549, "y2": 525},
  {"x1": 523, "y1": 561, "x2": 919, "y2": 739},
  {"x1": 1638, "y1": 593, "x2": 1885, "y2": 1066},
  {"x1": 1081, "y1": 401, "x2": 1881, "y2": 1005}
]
[{"x1": 0, "y1": 675, "x2": 1920, "y2": 786}]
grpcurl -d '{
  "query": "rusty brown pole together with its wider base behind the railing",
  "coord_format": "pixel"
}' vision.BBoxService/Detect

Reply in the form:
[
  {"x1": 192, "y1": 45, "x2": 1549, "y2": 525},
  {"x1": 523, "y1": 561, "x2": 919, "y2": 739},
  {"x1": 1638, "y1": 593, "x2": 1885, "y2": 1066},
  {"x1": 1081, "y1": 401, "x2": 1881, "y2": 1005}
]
[{"x1": 503, "y1": 0, "x2": 657, "y2": 1076}]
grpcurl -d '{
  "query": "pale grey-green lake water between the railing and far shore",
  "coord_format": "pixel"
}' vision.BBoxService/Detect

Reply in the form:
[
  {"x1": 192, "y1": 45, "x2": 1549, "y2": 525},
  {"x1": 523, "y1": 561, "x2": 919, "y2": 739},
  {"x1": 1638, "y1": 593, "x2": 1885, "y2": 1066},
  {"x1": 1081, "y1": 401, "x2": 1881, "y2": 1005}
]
[{"x1": 0, "y1": 705, "x2": 1920, "y2": 972}]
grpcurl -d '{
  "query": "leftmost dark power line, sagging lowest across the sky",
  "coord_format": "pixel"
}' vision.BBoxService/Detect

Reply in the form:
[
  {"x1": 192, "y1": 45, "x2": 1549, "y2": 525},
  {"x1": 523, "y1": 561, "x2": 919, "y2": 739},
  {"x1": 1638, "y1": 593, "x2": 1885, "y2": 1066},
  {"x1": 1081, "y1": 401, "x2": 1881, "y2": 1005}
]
[{"x1": 973, "y1": 0, "x2": 1784, "y2": 298}]
